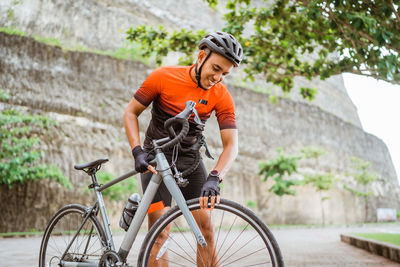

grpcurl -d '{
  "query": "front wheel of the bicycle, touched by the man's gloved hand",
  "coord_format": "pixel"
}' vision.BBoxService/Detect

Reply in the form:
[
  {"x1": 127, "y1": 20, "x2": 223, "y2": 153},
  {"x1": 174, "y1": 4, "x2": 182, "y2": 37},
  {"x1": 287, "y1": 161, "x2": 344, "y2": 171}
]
[{"x1": 138, "y1": 199, "x2": 284, "y2": 267}]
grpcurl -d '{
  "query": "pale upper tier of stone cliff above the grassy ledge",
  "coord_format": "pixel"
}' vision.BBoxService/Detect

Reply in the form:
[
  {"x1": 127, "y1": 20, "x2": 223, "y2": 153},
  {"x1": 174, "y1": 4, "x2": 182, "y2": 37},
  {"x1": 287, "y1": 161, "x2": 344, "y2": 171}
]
[{"x1": 0, "y1": 0, "x2": 361, "y2": 127}]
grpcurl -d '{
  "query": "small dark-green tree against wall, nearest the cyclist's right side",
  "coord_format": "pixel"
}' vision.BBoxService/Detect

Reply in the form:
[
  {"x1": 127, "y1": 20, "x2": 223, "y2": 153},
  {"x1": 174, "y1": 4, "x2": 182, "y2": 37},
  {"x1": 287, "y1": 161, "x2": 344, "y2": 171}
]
[{"x1": 259, "y1": 148, "x2": 301, "y2": 197}]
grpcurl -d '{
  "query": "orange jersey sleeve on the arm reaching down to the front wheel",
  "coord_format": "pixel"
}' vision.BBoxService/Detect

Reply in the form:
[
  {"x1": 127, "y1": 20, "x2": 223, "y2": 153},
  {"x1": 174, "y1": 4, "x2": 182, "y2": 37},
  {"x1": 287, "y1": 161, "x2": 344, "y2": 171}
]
[{"x1": 215, "y1": 91, "x2": 237, "y2": 130}]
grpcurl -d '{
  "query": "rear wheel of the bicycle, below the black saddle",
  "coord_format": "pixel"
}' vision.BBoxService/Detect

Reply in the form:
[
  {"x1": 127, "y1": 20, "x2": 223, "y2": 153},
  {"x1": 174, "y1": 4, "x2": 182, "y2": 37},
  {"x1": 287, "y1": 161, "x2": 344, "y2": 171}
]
[{"x1": 39, "y1": 204, "x2": 107, "y2": 267}]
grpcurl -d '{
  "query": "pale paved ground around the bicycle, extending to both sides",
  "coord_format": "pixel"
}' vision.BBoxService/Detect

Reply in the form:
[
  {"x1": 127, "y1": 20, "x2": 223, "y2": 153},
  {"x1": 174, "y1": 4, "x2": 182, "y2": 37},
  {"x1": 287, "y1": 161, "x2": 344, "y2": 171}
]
[{"x1": 0, "y1": 224, "x2": 400, "y2": 267}]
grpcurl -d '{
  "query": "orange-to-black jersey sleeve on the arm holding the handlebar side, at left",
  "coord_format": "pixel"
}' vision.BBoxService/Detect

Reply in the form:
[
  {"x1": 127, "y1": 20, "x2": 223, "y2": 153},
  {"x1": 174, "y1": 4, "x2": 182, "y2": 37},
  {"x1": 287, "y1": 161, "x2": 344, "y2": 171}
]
[{"x1": 134, "y1": 68, "x2": 163, "y2": 107}]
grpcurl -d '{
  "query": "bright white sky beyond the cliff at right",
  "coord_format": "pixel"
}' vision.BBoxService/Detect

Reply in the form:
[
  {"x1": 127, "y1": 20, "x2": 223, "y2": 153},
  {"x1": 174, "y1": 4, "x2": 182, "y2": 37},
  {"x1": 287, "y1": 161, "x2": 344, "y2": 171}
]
[{"x1": 343, "y1": 73, "x2": 400, "y2": 182}]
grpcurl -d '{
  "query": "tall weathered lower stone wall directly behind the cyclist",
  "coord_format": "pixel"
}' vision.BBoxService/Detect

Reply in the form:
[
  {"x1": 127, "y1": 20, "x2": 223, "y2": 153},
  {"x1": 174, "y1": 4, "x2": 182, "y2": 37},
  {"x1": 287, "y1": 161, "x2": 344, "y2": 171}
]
[{"x1": 0, "y1": 33, "x2": 400, "y2": 231}]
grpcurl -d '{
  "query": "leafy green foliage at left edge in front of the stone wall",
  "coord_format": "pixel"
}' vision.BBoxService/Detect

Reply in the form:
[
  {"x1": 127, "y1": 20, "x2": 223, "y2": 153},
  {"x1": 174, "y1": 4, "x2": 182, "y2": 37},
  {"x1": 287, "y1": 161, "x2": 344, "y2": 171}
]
[{"x1": 0, "y1": 95, "x2": 71, "y2": 188}]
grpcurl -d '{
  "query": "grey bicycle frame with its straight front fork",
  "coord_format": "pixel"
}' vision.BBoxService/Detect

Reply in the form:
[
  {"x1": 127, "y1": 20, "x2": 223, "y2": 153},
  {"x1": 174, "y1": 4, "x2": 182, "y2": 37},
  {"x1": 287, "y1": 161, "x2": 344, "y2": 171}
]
[{"x1": 62, "y1": 138, "x2": 207, "y2": 267}]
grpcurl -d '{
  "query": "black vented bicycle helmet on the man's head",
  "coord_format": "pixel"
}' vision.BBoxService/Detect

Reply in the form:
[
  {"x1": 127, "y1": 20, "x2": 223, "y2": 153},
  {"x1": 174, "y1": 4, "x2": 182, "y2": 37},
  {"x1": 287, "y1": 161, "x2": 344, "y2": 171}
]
[{"x1": 199, "y1": 32, "x2": 243, "y2": 67}]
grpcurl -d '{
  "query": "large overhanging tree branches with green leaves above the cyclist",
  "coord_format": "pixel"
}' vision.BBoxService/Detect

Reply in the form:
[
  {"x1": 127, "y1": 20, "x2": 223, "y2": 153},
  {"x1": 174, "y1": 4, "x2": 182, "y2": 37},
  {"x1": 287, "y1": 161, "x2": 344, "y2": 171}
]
[{"x1": 127, "y1": 0, "x2": 400, "y2": 100}]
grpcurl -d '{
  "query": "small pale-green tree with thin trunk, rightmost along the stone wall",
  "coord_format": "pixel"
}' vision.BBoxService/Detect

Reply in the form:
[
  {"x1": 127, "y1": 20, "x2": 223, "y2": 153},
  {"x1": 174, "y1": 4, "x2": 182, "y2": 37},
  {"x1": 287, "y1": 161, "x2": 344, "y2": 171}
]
[{"x1": 343, "y1": 157, "x2": 377, "y2": 222}]
